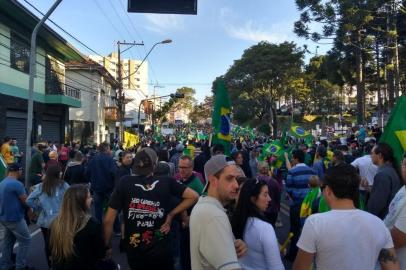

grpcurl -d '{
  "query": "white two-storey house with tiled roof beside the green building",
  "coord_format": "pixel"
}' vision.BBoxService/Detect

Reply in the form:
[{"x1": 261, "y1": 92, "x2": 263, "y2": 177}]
[{"x1": 66, "y1": 59, "x2": 119, "y2": 144}]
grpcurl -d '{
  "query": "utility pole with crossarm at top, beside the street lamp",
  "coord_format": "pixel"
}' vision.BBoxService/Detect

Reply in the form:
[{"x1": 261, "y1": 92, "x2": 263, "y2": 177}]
[{"x1": 117, "y1": 40, "x2": 144, "y2": 142}]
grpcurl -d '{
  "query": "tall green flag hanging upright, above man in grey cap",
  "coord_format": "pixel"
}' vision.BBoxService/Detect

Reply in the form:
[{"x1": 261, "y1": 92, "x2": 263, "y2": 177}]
[{"x1": 212, "y1": 80, "x2": 231, "y2": 155}]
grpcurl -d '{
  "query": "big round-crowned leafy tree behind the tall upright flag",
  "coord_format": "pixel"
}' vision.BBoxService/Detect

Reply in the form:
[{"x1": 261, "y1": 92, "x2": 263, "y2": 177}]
[{"x1": 219, "y1": 41, "x2": 304, "y2": 136}]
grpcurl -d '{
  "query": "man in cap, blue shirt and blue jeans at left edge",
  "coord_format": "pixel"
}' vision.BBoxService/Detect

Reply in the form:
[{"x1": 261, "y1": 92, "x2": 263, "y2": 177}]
[{"x1": 0, "y1": 163, "x2": 32, "y2": 269}]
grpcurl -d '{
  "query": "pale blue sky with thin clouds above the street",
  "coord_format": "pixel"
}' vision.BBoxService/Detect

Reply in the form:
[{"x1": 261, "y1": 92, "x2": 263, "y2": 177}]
[{"x1": 19, "y1": 0, "x2": 329, "y2": 101}]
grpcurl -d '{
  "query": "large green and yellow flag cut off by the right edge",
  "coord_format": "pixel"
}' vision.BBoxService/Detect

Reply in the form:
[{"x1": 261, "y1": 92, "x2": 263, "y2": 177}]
[{"x1": 379, "y1": 96, "x2": 406, "y2": 166}]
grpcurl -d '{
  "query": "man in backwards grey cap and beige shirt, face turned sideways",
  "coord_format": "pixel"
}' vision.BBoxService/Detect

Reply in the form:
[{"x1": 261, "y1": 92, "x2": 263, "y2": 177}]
[{"x1": 189, "y1": 155, "x2": 247, "y2": 270}]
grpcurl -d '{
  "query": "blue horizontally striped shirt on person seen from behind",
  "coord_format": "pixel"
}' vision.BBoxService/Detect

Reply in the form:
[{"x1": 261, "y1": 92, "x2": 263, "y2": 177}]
[{"x1": 286, "y1": 163, "x2": 315, "y2": 205}]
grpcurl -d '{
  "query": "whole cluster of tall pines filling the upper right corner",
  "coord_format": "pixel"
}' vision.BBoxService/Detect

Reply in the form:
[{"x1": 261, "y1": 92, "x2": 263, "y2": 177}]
[{"x1": 294, "y1": 0, "x2": 405, "y2": 123}]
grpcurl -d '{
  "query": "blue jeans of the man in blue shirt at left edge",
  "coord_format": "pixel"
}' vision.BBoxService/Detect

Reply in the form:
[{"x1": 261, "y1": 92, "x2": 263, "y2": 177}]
[{"x1": 0, "y1": 220, "x2": 31, "y2": 270}]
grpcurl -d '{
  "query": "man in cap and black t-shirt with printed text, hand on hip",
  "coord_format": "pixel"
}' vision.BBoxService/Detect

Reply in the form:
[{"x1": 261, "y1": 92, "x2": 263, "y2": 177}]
[{"x1": 103, "y1": 147, "x2": 198, "y2": 270}]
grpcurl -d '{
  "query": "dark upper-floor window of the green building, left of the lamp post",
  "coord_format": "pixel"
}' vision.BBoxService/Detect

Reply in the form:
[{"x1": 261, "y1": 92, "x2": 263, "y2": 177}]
[{"x1": 10, "y1": 32, "x2": 30, "y2": 74}]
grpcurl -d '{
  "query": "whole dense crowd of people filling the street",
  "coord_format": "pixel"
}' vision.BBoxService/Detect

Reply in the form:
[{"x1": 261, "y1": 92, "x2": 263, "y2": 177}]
[{"x1": 0, "y1": 125, "x2": 406, "y2": 270}]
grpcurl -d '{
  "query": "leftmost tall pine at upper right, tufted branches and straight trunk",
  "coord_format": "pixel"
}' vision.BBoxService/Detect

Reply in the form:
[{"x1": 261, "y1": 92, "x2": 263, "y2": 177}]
[{"x1": 294, "y1": 0, "x2": 380, "y2": 124}]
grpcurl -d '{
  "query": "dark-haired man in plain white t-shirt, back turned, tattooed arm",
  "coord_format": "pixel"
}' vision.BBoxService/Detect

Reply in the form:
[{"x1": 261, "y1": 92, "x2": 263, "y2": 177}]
[{"x1": 293, "y1": 164, "x2": 399, "y2": 270}]
